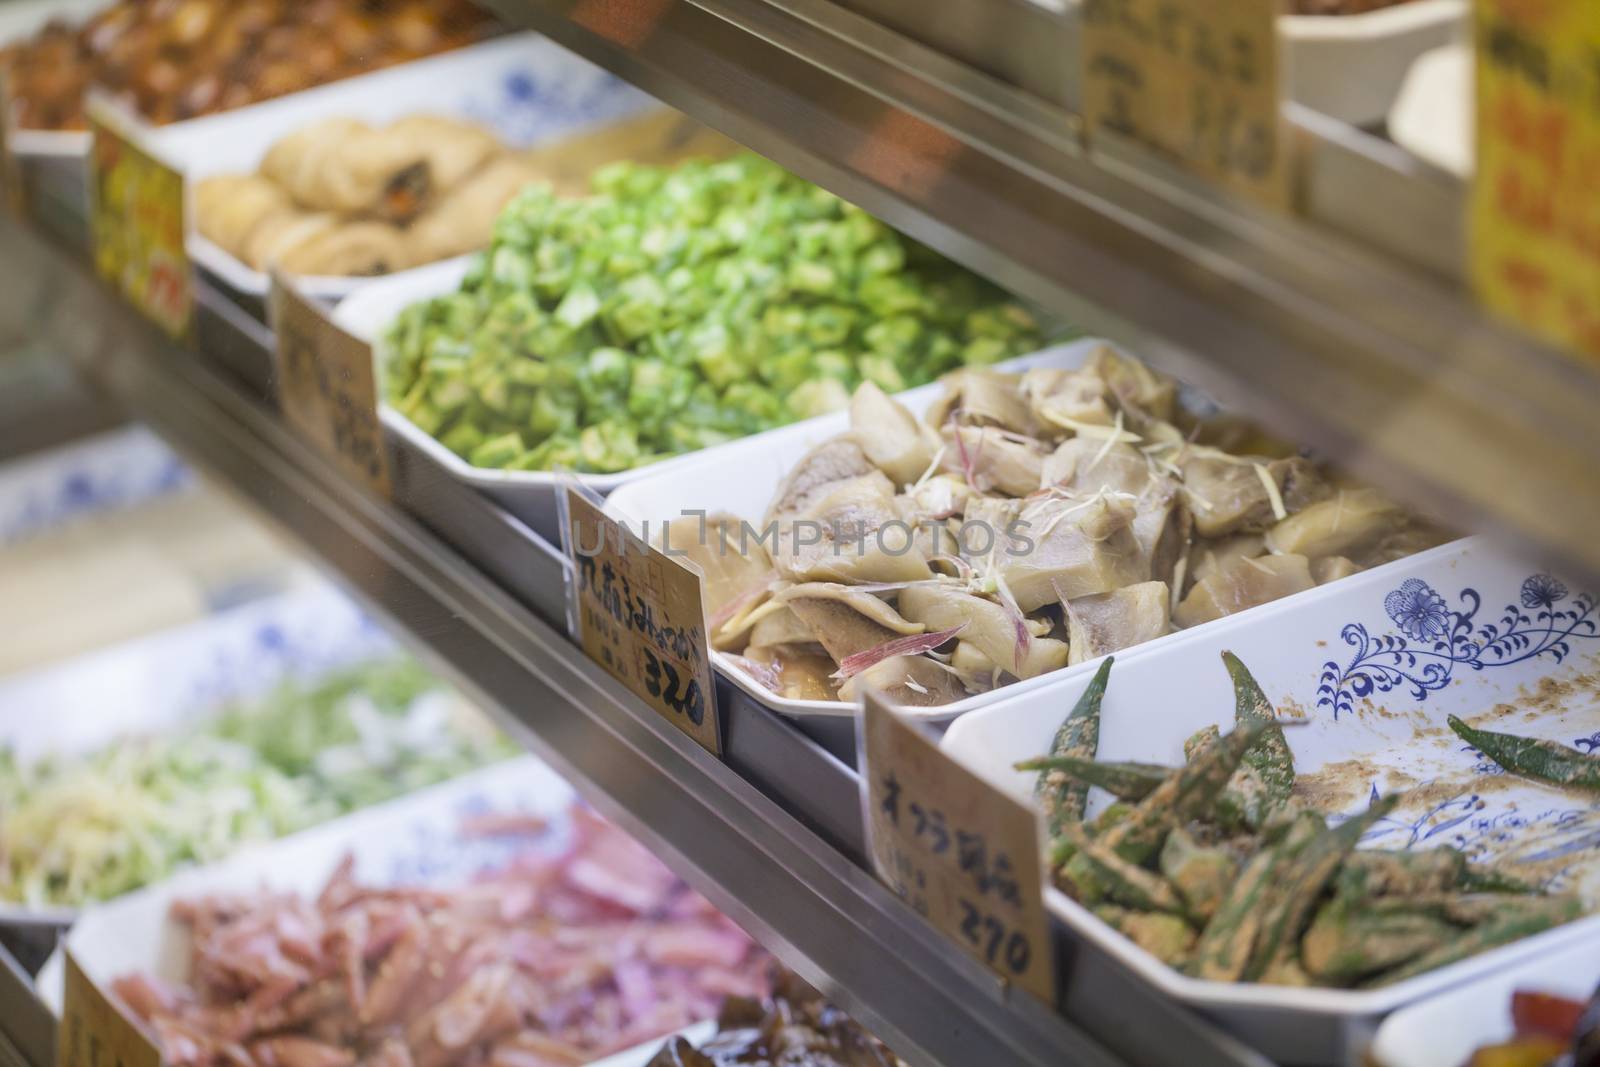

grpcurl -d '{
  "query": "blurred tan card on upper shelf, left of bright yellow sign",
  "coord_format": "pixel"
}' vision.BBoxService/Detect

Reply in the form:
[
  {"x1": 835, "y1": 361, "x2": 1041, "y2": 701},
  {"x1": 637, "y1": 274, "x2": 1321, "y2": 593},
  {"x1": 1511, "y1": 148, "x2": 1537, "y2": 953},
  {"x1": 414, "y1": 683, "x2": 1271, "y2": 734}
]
[{"x1": 1082, "y1": 0, "x2": 1291, "y2": 205}]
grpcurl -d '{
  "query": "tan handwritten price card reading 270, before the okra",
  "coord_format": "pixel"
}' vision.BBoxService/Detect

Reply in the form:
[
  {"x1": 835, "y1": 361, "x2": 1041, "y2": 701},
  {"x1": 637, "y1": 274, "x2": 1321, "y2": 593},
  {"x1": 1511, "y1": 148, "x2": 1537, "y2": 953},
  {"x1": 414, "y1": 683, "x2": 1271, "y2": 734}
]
[{"x1": 861, "y1": 693, "x2": 1056, "y2": 1005}]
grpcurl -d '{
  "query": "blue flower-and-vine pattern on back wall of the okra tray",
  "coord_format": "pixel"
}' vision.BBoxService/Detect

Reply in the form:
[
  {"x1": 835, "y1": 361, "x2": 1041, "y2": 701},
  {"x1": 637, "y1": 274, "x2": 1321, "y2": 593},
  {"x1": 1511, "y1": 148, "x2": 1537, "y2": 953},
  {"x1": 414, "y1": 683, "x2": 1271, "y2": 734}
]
[{"x1": 1317, "y1": 574, "x2": 1600, "y2": 723}]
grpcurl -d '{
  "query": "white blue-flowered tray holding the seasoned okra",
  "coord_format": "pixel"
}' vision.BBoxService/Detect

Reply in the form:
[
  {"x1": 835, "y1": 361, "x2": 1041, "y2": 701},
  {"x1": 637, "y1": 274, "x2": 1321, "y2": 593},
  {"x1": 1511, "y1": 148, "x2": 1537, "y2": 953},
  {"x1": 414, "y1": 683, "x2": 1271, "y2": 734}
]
[{"x1": 942, "y1": 539, "x2": 1600, "y2": 1064}]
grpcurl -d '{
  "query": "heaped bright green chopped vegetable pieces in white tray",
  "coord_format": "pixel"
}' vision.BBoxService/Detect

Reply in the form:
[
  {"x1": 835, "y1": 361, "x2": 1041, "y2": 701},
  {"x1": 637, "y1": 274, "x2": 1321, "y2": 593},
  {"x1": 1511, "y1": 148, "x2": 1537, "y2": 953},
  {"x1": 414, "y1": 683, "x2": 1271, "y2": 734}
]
[{"x1": 386, "y1": 155, "x2": 1040, "y2": 472}]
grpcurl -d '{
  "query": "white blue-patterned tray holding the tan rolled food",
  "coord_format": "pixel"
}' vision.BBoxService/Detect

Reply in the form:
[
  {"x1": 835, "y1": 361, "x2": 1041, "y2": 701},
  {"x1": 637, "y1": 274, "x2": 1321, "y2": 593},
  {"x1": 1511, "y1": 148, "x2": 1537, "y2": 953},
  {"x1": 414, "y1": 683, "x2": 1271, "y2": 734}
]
[{"x1": 137, "y1": 34, "x2": 658, "y2": 299}]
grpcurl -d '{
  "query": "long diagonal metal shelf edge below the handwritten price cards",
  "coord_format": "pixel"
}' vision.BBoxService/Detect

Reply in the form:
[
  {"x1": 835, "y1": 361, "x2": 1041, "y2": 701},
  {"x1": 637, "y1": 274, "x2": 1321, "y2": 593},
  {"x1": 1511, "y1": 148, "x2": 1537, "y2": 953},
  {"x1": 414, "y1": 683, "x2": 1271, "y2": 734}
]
[{"x1": 0, "y1": 218, "x2": 1262, "y2": 1067}]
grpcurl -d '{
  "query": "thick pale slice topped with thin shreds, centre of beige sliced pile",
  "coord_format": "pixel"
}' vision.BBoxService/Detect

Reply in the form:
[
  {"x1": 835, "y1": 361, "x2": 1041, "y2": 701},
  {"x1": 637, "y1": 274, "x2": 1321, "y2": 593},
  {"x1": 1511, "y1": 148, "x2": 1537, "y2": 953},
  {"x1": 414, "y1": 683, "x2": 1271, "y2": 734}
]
[{"x1": 995, "y1": 496, "x2": 1150, "y2": 611}]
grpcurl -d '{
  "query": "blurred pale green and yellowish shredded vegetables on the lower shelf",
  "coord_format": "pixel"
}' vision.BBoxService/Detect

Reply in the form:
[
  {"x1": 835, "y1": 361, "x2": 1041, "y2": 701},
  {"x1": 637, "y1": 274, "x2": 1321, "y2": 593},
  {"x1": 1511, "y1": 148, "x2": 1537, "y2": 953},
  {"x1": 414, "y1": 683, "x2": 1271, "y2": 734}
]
[{"x1": 0, "y1": 659, "x2": 515, "y2": 907}]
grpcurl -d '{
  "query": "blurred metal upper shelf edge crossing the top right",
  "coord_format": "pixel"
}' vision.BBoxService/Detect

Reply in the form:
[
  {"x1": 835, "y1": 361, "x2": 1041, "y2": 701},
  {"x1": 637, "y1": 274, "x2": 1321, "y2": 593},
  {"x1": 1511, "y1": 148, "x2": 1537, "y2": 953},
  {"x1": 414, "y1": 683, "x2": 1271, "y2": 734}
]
[{"x1": 490, "y1": 0, "x2": 1600, "y2": 591}]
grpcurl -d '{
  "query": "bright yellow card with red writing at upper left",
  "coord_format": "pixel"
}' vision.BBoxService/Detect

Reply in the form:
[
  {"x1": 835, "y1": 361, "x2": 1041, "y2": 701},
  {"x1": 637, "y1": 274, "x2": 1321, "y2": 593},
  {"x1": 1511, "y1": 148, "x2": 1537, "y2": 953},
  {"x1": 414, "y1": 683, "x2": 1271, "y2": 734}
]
[{"x1": 88, "y1": 93, "x2": 194, "y2": 338}]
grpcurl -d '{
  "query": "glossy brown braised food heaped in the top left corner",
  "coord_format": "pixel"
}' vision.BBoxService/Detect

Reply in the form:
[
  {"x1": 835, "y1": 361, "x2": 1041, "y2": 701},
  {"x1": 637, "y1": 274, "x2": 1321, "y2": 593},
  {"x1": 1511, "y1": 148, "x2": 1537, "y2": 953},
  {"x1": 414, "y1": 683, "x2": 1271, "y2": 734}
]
[{"x1": 0, "y1": 0, "x2": 496, "y2": 130}]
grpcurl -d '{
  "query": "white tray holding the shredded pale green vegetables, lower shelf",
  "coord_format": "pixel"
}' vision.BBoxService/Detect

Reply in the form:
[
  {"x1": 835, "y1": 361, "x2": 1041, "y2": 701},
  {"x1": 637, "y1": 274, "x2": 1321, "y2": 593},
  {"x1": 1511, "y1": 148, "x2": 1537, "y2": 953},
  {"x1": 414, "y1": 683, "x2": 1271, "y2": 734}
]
[{"x1": 0, "y1": 584, "x2": 400, "y2": 926}]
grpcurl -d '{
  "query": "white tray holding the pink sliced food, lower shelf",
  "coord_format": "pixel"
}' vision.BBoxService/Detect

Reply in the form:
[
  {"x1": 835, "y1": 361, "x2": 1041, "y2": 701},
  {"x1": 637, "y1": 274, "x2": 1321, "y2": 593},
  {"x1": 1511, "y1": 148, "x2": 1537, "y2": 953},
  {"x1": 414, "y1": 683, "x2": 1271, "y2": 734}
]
[{"x1": 38, "y1": 757, "x2": 714, "y2": 1067}]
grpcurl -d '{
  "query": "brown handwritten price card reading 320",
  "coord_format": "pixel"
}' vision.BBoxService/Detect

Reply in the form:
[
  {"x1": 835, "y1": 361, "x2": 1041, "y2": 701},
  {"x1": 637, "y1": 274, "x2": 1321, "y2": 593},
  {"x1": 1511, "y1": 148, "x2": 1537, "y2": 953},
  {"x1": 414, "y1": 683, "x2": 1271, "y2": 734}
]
[{"x1": 566, "y1": 486, "x2": 722, "y2": 757}]
